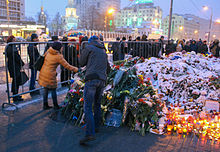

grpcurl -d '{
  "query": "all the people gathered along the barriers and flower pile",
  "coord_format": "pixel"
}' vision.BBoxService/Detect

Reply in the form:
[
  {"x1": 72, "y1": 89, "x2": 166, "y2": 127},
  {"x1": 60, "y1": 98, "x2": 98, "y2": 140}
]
[{"x1": 6, "y1": 34, "x2": 220, "y2": 144}]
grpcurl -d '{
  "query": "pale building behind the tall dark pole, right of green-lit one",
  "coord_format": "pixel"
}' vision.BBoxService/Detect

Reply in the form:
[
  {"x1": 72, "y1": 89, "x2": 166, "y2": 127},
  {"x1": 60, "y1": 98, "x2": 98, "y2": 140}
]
[{"x1": 162, "y1": 14, "x2": 200, "y2": 40}]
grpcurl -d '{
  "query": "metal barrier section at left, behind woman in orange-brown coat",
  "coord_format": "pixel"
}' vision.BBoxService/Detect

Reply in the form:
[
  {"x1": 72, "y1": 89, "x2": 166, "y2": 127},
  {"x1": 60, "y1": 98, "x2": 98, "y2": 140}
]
[{"x1": 2, "y1": 42, "x2": 79, "y2": 107}]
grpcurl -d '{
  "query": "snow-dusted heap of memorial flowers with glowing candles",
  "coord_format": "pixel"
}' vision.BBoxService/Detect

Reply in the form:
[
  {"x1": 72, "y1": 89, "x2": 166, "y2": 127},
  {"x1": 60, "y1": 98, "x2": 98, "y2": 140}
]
[{"x1": 63, "y1": 52, "x2": 220, "y2": 140}]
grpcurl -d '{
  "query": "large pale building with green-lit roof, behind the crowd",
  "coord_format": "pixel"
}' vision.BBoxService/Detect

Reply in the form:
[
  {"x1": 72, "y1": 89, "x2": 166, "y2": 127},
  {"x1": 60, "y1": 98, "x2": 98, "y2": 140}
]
[{"x1": 115, "y1": 0, "x2": 163, "y2": 36}]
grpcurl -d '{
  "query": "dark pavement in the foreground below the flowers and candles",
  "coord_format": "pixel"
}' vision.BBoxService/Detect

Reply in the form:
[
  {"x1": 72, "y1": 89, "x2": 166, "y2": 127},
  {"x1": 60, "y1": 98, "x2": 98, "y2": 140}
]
[{"x1": 0, "y1": 89, "x2": 220, "y2": 152}]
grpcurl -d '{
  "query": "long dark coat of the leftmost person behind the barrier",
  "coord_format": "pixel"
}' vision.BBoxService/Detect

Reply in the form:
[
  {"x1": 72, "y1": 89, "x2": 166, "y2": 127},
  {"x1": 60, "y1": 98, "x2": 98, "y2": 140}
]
[{"x1": 6, "y1": 45, "x2": 24, "y2": 78}]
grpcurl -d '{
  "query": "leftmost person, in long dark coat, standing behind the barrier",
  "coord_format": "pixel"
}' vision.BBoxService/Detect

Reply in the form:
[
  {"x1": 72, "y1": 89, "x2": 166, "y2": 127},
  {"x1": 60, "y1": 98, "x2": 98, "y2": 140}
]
[{"x1": 6, "y1": 35, "x2": 24, "y2": 102}]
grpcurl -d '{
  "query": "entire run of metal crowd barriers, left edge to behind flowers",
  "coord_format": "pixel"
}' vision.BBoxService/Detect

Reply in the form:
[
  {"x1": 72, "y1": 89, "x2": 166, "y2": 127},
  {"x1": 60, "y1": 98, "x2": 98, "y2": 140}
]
[{"x1": 3, "y1": 41, "x2": 161, "y2": 107}]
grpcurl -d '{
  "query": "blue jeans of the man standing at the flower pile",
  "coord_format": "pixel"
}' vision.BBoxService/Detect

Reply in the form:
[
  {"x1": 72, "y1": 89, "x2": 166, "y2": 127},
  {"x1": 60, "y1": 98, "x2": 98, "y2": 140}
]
[{"x1": 83, "y1": 79, "x2": 105, "y2": 136}]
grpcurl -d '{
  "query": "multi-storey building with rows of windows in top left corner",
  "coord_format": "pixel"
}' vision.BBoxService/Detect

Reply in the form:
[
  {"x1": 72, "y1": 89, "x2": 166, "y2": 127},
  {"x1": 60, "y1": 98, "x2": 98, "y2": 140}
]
[{"x1": 0, "y1": 0, "x2": 25, "y2": 21}]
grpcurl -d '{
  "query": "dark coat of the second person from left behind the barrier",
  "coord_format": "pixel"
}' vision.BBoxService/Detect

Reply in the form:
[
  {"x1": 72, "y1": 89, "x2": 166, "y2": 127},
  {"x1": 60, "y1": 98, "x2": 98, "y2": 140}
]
[{"x1": 27, "y1": 44, "x2": 40, "y2": 69}]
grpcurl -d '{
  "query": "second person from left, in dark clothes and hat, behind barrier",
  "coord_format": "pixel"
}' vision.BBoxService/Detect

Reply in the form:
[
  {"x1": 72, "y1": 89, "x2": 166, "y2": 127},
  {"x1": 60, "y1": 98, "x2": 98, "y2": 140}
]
[{"x1": 27, "y1": 33, "x2": 40, "y2": 95}]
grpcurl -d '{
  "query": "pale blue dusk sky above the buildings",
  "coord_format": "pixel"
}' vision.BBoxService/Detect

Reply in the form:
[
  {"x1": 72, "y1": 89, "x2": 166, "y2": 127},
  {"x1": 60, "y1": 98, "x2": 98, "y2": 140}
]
[{"x1": 26, "y1": 0, "x2": 220, "y2": 20}]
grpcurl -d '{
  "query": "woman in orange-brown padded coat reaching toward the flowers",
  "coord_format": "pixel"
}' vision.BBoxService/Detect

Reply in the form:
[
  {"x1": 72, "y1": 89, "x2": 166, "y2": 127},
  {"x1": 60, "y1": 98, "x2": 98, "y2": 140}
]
[{"x1": 39, "y1": 42, "x2": 78, "y2": 110}]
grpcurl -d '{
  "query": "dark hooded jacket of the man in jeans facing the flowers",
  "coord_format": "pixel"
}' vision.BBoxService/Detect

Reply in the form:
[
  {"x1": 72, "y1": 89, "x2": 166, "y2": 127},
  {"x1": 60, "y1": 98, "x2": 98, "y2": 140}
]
[{"x1": 79, "y1": 41, "x2": 110, "y2": 81}]
